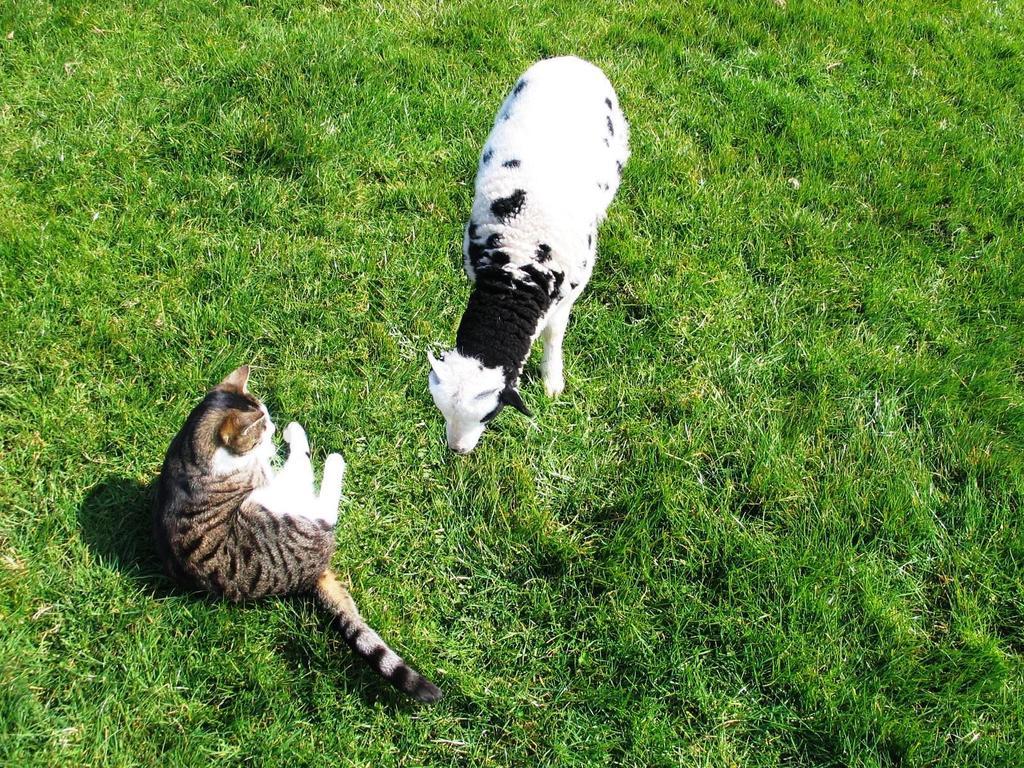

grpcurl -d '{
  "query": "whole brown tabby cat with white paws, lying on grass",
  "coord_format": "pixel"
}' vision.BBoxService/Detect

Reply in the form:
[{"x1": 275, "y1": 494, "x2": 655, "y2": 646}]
[{"x1": 154, "y1": 366, "x2": 441, "y2": 701}]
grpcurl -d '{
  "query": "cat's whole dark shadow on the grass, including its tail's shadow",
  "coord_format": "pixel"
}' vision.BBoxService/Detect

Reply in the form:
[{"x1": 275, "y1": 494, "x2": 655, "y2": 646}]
[{"x1": 72, "y1": 477, "x2": 440, "y2": 713}]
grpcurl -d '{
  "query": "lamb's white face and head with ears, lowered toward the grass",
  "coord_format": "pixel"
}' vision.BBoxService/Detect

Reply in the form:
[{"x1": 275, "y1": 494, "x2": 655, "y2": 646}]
[{"x1": 427, "y1": 351, "x2": 530, "y2": 454}]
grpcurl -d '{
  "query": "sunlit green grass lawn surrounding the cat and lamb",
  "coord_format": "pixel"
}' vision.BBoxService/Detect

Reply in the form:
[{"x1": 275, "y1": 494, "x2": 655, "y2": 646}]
[{"x1": 0, "y1": 0, "x2": 1024, "y2": 767}]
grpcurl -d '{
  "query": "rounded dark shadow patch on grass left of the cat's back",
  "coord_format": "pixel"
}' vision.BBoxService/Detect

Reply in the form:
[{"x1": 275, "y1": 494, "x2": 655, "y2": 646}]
[{"x1": 78, "y1": 477, "x2": 175, "y2": 594}]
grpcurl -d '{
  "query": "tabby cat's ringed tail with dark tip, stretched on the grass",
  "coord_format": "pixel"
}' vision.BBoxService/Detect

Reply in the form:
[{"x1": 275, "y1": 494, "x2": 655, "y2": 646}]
[{"x1": 316, "y1": 568, "x2": 441, "y2": 701}]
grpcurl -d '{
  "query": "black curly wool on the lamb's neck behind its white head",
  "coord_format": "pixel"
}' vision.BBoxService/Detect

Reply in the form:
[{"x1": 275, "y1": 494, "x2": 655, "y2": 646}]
[{"x1": 456, "y1": 266, "x2": 551, "y2": 385}]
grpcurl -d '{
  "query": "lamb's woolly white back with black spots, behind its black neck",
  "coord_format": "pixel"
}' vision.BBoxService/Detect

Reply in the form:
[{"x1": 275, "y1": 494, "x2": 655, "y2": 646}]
[{"x1": 469, "y1": 56, "x2": 629, "y2": 268}]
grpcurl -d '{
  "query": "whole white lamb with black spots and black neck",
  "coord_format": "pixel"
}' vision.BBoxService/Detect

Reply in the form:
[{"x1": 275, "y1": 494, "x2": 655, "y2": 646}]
[{"x1": 427, "y1": 56, "x2": 629, "y2": 454}]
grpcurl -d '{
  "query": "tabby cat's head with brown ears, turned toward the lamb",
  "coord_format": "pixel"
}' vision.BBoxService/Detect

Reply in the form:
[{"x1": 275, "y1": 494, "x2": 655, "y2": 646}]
[{"x1": 183, "y1": 366, "x2": 274, "y2": 474}]
